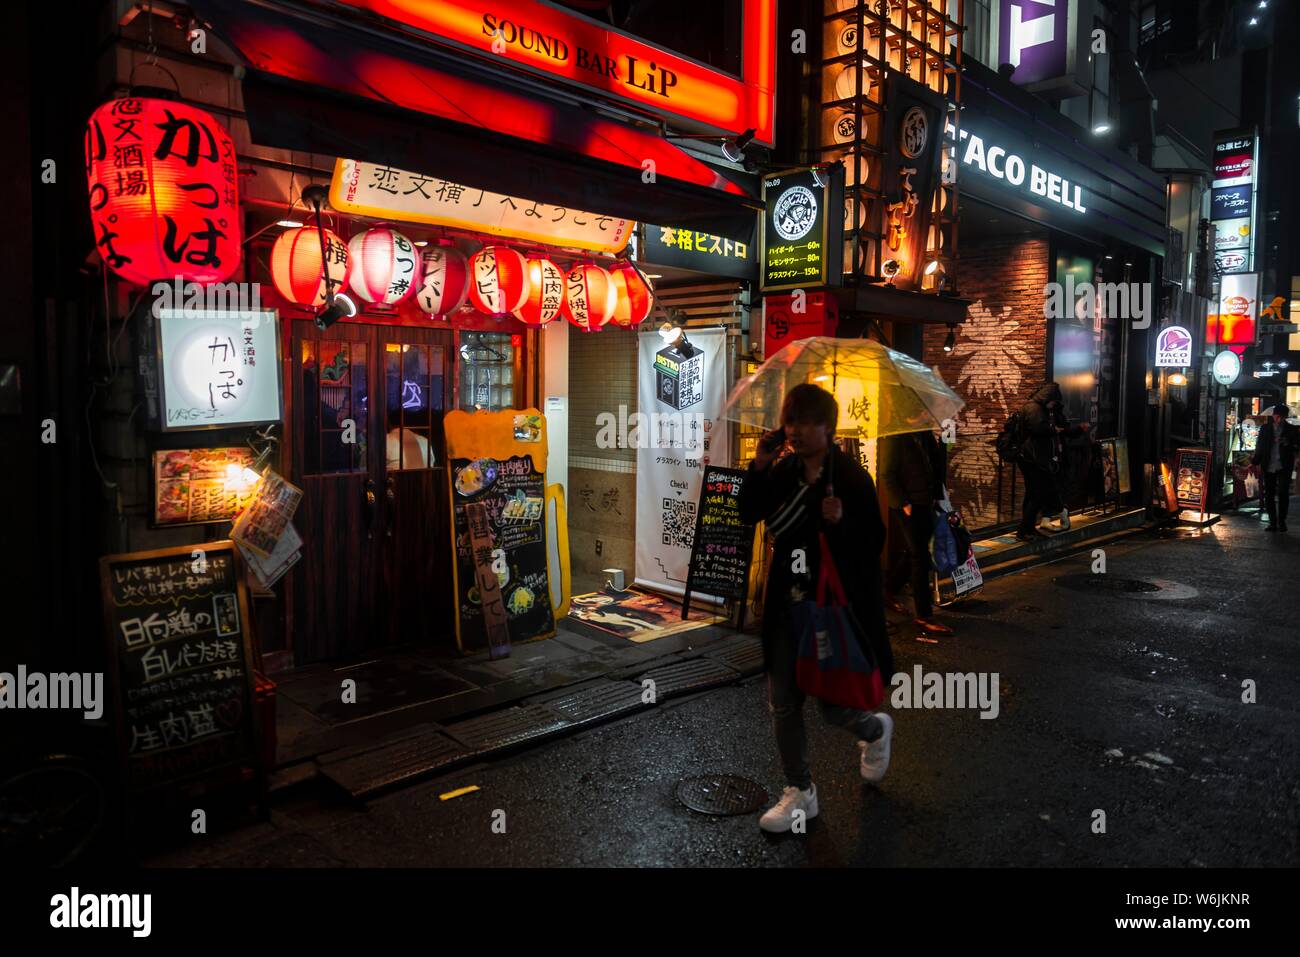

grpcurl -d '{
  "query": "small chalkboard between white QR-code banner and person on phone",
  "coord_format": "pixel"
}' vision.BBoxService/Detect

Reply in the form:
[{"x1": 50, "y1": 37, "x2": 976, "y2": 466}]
[{"x1": 681, "y1": 465, "x2": 754, "y2": 618}]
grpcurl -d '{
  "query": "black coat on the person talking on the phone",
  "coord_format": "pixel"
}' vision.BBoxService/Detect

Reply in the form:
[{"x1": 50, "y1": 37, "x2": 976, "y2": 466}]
[{"x1": 740, "y1": 446, "x2": 893, "y2": 685}]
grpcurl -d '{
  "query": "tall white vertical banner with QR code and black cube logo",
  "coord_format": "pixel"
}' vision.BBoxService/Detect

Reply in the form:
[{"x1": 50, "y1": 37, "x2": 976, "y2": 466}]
[{"x1": 629, "y1": 329, "x2": 731, "y2": 594}]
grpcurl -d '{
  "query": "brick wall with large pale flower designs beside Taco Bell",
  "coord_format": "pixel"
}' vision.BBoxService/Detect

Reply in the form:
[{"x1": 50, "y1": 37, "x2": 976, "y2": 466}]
[{"x1": 923, "y1": 234, "x2": 1049, "y2": 528}]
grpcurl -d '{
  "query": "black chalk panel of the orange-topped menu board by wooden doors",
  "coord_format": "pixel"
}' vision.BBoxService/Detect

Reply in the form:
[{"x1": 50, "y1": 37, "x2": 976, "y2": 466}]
[{"x1": 450, "y1": 455, "x2": 555, "y2": 651}]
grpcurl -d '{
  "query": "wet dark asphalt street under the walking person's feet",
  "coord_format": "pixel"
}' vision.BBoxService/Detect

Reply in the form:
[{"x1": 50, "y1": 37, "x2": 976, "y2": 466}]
[{"x1": 151, "y1": 516, "x2": 1300, "y2": 867}]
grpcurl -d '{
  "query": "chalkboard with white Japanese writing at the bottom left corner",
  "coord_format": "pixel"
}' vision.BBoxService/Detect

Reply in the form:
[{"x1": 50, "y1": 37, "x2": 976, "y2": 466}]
[{"x1": 99, "y1": 541, "x2": 261, "y2": 793}]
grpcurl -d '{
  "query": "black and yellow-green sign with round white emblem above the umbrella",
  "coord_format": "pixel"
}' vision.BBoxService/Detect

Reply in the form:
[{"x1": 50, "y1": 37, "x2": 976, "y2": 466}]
[{"x1": 758, "y1": 164, "x2": 844, "y2": 290}]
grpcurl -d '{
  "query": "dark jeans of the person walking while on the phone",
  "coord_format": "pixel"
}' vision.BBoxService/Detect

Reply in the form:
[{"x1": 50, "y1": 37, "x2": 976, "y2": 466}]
[{"x1": 763, "y1": 619, "x2": 884, "y2": 791}]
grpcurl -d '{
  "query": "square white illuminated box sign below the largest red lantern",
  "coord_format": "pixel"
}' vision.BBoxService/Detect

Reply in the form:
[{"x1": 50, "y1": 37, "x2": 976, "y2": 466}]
[{"x1": 157, "y1": 309, "x2": 283, "y2": 430}]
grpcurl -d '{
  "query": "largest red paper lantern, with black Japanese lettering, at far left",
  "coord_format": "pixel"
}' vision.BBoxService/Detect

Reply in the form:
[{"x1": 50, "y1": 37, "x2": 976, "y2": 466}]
[{"x1": 86, "y1": 96, "x2": 242, "y2": 285}]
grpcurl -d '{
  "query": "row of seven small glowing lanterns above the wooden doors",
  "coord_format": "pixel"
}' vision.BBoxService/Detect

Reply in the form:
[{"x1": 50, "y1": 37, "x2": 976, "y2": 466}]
[{"x1": 270, "y1": 226, "x2": 654, "y2": 332}]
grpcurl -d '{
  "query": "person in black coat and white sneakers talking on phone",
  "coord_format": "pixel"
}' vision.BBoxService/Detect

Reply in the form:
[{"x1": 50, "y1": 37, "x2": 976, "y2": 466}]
[{"x1": 740, "y1": 384, "x2": 893, "y2": 831}]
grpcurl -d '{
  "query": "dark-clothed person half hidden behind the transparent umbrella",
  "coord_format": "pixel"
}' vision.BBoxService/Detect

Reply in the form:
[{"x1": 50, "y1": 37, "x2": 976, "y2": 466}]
[{"x1": 878, "y1": 432, "x2": 953, "y2": 635}]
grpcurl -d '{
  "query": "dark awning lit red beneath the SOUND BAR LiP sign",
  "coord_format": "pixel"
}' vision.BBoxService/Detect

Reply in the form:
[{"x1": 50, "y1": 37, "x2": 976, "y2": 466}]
[{"x1": 194, "y1": 0, "x2": 762, "y2": 242}]
